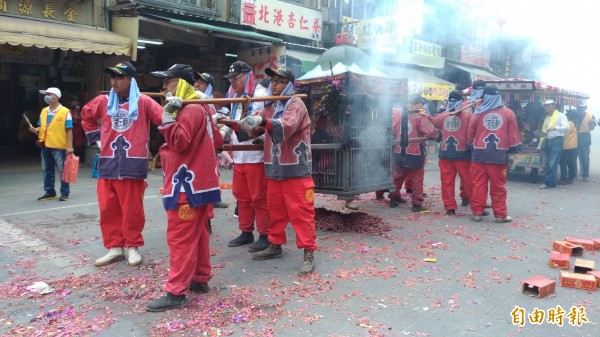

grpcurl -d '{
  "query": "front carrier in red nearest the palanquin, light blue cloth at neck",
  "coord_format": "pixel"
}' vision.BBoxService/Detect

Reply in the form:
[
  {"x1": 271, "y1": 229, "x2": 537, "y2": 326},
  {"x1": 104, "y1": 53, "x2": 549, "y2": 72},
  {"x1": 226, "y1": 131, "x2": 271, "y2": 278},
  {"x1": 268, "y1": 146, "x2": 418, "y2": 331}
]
[{"x1": 238, "y1": 68, "x2": 317, "y2": 275}]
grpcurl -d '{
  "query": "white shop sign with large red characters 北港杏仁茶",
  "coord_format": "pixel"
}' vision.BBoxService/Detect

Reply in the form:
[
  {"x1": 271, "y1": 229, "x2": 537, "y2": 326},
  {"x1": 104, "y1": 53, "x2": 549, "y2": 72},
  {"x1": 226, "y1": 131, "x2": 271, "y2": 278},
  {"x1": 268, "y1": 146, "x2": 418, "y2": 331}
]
[{"x1": 240, "y1": 0, "x2": 323, "y2": 41}]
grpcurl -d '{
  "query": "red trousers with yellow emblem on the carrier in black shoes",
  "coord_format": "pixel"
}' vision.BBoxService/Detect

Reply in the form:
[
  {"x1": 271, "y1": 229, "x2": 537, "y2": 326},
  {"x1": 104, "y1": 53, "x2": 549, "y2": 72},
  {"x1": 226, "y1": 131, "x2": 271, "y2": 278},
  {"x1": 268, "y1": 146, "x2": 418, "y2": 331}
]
[{"x1": 166, "y1": 193, "x2": 211, "y2": 295}]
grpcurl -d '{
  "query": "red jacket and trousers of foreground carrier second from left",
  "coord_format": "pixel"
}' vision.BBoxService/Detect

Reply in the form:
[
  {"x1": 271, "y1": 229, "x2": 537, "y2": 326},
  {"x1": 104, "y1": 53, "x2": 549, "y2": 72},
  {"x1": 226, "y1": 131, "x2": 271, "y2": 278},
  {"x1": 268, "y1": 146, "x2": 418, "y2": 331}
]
[{"x1": 158, "y1": 104, "x2": 223, "y2": 295}]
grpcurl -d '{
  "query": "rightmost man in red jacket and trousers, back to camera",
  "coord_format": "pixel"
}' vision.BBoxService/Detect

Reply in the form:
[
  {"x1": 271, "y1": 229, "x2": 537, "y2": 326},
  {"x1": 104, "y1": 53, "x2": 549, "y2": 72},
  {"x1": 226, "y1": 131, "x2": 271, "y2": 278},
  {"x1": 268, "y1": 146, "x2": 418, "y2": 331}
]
[{"x1": 467, "y1": 86, "x2": 521, "y2": 223}]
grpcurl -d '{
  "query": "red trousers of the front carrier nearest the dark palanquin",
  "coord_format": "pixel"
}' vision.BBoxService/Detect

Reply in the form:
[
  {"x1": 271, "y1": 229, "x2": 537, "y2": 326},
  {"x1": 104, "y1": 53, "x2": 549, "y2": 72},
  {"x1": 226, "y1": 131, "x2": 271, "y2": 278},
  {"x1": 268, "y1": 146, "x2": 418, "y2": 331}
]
[{"x1": 264, "y1": 177, "x2": 317, "y2": 250}]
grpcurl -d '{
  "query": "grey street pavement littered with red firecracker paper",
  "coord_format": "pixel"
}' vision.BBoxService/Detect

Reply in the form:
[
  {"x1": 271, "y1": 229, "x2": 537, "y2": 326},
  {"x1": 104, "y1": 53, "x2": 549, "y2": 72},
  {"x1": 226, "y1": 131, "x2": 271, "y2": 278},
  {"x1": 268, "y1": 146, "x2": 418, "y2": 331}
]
[{"x1": 0, "y1": 148, "x2": 600, "y2": 337}]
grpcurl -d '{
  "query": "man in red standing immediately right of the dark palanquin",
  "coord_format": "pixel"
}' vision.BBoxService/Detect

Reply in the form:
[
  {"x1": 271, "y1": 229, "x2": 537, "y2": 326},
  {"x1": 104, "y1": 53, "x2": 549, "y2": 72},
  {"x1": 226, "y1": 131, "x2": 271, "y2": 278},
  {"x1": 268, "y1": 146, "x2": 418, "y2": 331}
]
[{"x1": 390, "y1": 94, "x2": 438, "y2": 212}]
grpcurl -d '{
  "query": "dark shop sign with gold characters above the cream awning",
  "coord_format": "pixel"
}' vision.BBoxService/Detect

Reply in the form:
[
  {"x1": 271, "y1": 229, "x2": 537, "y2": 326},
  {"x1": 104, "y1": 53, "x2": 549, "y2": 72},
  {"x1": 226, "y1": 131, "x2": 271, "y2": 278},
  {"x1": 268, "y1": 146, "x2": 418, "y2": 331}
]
[{"x1": 0, "y1": 0, "x2": 94, "y2": 26}]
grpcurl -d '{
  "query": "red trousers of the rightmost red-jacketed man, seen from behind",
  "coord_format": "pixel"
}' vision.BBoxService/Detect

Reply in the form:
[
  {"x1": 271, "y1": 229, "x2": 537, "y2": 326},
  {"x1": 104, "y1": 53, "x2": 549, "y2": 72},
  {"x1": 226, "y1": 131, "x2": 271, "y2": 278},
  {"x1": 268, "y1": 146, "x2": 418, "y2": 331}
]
[{"x1": 471, "y1": 162, "x2": 507, "y2": 218}]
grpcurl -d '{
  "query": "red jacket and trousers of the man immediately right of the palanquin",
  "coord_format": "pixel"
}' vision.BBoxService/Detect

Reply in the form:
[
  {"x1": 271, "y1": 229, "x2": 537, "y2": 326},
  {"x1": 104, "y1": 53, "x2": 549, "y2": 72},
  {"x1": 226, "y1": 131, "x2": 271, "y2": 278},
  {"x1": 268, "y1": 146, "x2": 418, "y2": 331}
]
[{"x1": 392, "y1": 108, "x2": 438, "y2": 205}]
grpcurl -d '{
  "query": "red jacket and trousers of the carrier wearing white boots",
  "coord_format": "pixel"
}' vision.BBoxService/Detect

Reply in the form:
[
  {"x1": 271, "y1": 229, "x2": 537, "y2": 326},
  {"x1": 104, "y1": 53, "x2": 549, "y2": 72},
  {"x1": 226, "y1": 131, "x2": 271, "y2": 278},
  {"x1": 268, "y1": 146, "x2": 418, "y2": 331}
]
[{"x1": 81, "y1": 95, "x2": 162, "y2": 249}]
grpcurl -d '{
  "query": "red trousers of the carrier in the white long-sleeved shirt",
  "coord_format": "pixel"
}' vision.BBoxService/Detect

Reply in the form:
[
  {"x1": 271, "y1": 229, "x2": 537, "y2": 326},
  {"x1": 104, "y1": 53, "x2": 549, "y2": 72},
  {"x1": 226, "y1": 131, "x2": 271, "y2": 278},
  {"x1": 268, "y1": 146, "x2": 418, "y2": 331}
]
[{"x1": 232, "y1": 163, "x2": 269, "y2": 235}]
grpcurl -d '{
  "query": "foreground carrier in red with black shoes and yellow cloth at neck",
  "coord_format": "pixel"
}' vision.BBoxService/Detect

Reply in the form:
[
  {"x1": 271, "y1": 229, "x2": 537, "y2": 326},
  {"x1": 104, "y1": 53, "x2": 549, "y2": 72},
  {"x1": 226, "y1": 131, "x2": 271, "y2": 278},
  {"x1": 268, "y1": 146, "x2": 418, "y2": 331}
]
[{"x1": 146, "y1": 64, "x2": 223, "y2": 312}]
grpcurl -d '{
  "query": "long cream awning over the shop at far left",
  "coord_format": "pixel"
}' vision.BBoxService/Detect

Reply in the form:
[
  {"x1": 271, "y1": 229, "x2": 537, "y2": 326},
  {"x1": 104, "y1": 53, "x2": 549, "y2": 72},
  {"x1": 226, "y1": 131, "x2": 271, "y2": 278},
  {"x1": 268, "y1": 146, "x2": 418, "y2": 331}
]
[{"x1": 0, "y1": 15, "x2": 131, "y2": 56}]
